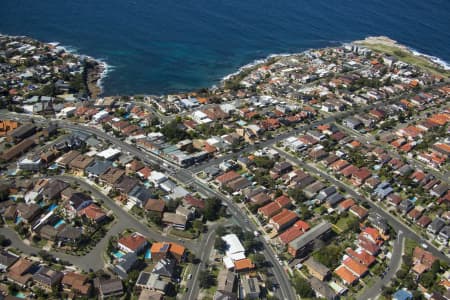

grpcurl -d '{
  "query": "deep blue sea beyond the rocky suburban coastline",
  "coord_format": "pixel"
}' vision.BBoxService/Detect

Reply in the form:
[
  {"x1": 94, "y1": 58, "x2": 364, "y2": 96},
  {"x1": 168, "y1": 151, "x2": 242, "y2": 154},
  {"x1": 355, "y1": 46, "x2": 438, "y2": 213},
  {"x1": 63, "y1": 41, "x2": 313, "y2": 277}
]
[{"x1": 0, "y1": 0, "x2": 450, "y2": 95}]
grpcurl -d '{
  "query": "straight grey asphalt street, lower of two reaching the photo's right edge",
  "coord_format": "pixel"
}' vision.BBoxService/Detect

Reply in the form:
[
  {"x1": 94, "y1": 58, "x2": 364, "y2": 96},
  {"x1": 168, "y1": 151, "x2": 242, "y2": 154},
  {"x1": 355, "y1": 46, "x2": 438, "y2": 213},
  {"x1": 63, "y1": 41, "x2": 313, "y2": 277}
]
[{"x1": 277, "y1": 148, "x2": 450, "y2": 263}]
